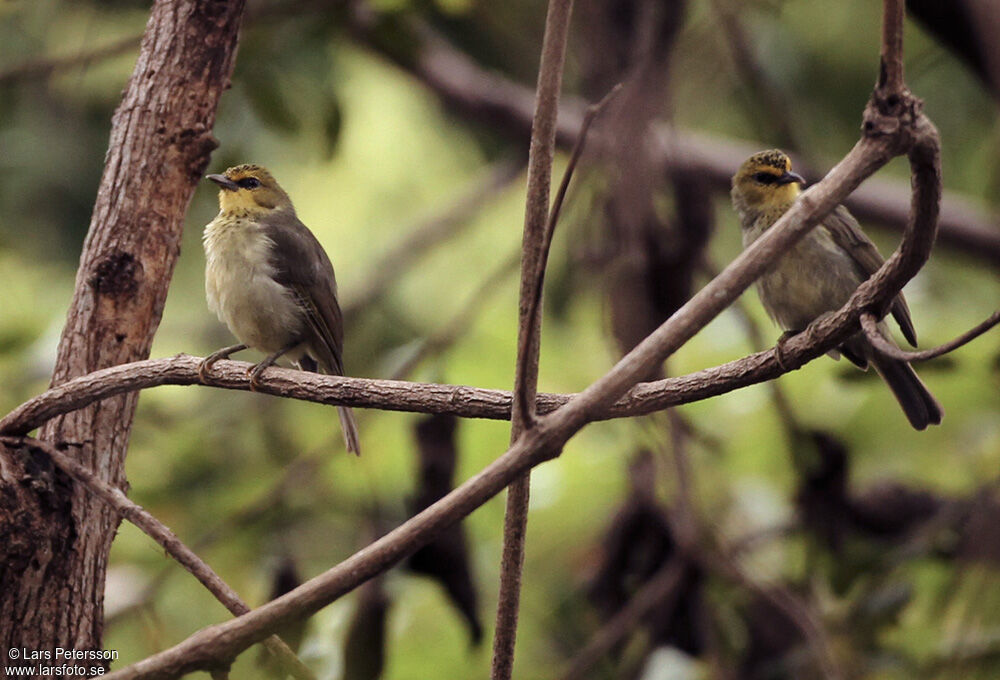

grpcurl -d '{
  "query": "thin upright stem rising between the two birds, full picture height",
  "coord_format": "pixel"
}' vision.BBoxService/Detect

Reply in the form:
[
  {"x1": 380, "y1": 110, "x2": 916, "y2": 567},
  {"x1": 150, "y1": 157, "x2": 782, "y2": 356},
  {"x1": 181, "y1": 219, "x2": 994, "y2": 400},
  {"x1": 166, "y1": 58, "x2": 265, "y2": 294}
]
[{"x1": 490, "y1": 0, "x2": 573, "y2": 680}]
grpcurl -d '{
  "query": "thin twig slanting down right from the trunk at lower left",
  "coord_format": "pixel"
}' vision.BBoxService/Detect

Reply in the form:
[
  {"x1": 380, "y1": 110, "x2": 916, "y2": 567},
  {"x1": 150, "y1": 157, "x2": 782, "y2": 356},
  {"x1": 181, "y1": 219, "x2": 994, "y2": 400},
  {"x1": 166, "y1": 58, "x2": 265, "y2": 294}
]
[{"x1": 0, "y1": 436, "x2": 316, "y2": 680}]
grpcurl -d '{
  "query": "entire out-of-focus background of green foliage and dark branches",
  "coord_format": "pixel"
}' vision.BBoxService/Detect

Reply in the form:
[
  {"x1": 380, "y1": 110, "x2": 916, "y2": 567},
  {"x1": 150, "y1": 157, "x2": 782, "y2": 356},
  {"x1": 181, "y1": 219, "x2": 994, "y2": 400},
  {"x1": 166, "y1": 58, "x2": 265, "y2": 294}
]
[{"x1": 0, "y1": 0, "x2": 1000, "y2": 680}]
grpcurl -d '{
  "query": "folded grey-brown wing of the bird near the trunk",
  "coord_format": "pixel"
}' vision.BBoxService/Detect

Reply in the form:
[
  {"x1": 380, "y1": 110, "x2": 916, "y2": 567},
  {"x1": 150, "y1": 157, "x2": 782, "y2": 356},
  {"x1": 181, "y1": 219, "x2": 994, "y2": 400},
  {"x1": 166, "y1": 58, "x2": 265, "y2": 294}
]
[{"x1": 264, "y1": 211, "x2": 344, "y2": 375}]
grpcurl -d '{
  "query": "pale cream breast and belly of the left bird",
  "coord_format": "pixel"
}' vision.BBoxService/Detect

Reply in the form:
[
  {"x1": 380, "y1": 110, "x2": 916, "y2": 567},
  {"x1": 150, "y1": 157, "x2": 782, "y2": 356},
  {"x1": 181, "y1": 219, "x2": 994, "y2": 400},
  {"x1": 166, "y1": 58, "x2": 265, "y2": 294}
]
[{"x1": 203, "y1": 218, "x2": 302, "y2": 352}]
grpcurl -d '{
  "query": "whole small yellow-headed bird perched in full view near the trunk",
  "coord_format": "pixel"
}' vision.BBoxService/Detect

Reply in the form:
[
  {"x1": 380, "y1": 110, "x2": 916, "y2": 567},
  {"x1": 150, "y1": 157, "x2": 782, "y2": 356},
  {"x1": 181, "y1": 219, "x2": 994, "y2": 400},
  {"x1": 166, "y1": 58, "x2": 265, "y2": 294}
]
[{"x1": 198, "y1": 165, "x2": 361, "y2": 454}]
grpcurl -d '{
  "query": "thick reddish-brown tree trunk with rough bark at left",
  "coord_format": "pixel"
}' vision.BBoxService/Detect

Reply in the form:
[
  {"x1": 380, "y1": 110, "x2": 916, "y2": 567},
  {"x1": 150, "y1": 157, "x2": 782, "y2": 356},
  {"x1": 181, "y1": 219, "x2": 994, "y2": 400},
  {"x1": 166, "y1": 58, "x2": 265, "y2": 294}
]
[{"x1": 0, "y1": 0, "x2": 244, "y2": 665}]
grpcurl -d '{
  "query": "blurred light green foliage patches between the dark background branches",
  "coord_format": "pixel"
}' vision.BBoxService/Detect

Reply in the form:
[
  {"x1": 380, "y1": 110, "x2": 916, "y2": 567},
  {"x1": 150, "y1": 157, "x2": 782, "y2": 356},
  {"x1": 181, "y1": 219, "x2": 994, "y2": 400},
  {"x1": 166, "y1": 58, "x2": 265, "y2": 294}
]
[{"x1": 0, "y1": 0, "x2": 1000, "y2": 680}]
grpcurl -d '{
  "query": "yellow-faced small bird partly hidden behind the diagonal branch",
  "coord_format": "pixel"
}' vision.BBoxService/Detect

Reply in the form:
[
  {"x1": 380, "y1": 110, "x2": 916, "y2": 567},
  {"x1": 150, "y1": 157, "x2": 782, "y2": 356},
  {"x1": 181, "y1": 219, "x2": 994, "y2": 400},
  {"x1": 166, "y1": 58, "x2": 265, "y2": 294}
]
[{"x1": 732, "y1": 149, "x2": 943, "y2": 430}]
